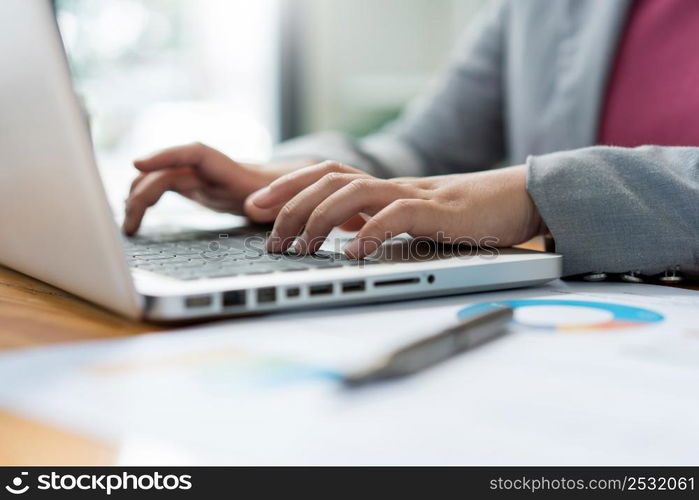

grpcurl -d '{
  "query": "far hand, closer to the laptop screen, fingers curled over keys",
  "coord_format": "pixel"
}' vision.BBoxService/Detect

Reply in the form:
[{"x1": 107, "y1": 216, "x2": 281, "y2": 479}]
[{"x1": 123, "y1": 143, "x2": 310, "y2": 234}]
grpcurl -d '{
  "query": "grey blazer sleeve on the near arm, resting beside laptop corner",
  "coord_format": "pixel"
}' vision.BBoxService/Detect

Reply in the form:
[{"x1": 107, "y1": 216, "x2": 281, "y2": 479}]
[{"x1": 527, "y1": 146, "x2": 699, "y2": 275}]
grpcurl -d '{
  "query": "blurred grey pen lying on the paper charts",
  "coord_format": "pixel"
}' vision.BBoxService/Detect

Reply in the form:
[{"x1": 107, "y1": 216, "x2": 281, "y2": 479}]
[{"x1": 343, "y1": 306, "x2": 513, "y2": 387}]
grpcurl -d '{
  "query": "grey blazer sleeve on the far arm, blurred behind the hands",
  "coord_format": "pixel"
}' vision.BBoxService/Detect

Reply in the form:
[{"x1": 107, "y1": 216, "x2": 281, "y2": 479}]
[{"x1": 274, "y1": 0, "x2": 507, "y2": 177}]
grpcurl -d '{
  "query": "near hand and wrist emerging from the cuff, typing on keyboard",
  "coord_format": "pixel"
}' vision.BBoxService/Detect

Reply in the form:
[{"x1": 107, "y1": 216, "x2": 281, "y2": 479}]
[{"x1": 246, "y1": 162, "x2": 544, "y2": 258}]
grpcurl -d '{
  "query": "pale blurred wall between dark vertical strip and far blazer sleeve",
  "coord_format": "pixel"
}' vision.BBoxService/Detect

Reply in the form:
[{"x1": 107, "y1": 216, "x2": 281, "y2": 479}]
[{"x1": 297, "y1": 0, "x2": 487, "y2": 134}]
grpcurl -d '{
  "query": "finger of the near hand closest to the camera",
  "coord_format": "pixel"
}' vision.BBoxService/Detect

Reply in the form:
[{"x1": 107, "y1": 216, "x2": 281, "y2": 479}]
[{"x1": 345, "y1": 199, "x2": 440, "y2": 259}]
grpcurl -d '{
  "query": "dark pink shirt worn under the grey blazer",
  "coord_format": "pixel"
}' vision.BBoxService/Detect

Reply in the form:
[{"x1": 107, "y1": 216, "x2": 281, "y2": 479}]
[{"x1": 598, "y1": 0, "x2": 699, "y2": 147}]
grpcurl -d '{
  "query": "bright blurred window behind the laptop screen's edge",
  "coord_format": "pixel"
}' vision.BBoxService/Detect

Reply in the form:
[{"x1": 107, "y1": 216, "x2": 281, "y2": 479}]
[{"x1": 56, "y1": 0, "x2": 279, "y2": 159}]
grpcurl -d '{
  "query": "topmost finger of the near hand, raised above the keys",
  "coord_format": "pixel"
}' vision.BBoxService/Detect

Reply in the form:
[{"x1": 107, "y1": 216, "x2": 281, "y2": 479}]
[{"x1": 251, "y1": 161, "x2": 363, "y2": 208}]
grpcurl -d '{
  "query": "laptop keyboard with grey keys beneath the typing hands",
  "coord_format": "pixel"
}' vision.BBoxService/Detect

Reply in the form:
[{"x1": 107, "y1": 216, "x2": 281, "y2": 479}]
[{"x1": 124, "y1": 233, "x2": 379, "y2": 280}]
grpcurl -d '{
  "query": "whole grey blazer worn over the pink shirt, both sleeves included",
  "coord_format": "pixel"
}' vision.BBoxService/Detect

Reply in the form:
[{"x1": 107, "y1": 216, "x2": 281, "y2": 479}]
[{"x1": 278, "y1": 0, "x2": 699, "y2": 275}]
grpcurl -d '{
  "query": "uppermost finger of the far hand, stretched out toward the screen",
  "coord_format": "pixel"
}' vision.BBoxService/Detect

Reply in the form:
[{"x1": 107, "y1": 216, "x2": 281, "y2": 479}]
[{"x1": 134, "y1": 142, "x2": 237, "y2": 183}]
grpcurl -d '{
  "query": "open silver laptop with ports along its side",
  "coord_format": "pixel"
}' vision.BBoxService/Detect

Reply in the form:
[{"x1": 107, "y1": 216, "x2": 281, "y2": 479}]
[{"x1": 0, "y1": 0, "x2": 561, "y2": 322}]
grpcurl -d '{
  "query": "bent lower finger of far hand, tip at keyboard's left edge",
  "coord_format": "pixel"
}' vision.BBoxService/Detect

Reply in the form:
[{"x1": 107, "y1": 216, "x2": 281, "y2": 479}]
[{"x1": 123, "y1": 168, "x2": 205, "y2": 234}]
